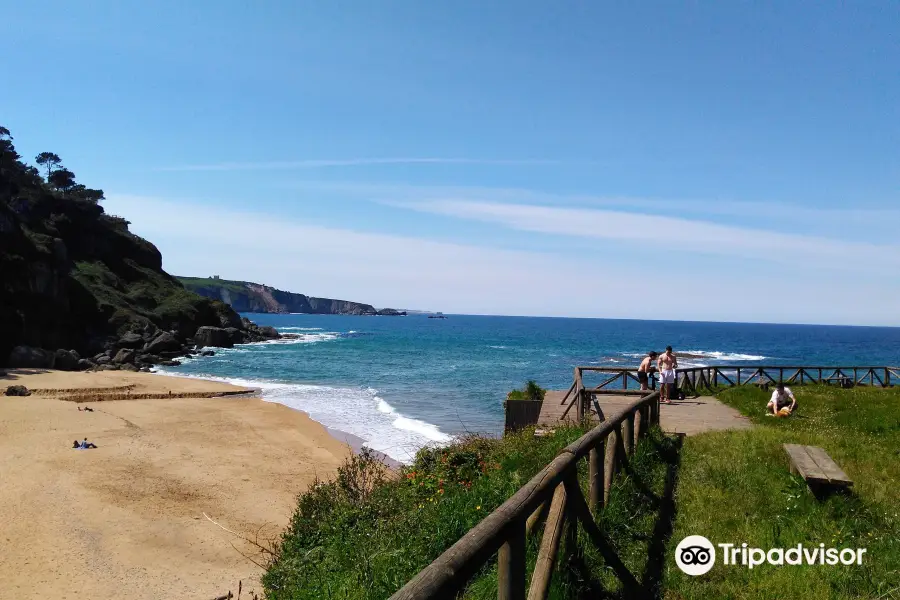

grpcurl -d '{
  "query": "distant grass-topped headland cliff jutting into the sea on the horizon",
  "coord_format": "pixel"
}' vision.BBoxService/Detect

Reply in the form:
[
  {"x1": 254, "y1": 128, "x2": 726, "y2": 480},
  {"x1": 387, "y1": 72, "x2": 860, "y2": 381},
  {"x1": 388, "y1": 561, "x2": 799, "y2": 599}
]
[{"x1": 178, "y1": 277, "x2": 405, "y2": 316}]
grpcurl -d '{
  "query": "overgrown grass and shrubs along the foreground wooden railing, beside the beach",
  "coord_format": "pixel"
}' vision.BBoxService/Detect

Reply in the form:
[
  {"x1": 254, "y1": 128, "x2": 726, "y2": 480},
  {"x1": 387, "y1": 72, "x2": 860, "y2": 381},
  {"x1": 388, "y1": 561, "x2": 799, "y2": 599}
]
[{"x1": 264, "y1": 427, "x2": 675, "y2": 600}]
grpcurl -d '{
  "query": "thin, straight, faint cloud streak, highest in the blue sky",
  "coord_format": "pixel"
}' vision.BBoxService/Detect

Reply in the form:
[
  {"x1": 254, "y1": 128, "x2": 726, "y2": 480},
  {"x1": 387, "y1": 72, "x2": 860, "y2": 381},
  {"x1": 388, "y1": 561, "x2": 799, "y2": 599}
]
[{"x1": 156, "y1": 157, "x2": 568, "y2": 171}]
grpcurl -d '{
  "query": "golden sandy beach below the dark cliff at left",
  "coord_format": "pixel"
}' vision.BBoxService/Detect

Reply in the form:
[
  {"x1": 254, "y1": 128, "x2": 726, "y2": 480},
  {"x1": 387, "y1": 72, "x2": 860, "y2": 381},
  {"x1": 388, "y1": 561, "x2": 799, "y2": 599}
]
[{"x1": 0, "y1": 369, "x2": 350, "y2": 600}]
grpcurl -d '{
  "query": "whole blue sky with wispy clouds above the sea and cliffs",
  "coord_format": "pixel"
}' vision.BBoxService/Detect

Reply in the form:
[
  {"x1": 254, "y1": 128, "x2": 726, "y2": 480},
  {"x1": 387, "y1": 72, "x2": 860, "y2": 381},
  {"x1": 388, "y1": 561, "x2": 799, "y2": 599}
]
[{"x1": 0, "y1": 0, "x2": 900, "y2": 325}]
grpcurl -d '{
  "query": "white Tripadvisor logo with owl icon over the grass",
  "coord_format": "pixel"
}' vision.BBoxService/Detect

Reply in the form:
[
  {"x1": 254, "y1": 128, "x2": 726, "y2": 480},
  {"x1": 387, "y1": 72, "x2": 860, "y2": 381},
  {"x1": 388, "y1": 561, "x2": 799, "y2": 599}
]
[{"x1": 675, "y1": 535, "x2": 866, "y2": 576}]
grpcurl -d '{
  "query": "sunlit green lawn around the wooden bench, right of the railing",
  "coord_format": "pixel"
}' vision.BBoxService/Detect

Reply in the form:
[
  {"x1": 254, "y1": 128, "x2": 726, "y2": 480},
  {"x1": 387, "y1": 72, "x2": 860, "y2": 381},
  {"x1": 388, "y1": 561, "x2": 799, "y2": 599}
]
[{"x1": 664, "y1": 386, "x2": 900, "y2": 599}]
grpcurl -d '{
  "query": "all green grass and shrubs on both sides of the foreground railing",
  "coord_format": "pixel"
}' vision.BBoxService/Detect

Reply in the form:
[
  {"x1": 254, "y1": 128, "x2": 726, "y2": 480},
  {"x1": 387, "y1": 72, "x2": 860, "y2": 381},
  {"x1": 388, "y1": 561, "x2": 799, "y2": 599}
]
[{"x1": 264, "y1": 386, "x2": 900, "y2": 600}]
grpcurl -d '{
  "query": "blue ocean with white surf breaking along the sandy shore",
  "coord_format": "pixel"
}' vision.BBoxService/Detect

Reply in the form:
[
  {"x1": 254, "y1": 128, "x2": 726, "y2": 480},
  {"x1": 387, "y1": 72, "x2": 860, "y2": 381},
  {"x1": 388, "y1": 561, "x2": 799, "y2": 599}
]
[{"x1": 160, "y1": 314, "x2": 900, "y2": 462}]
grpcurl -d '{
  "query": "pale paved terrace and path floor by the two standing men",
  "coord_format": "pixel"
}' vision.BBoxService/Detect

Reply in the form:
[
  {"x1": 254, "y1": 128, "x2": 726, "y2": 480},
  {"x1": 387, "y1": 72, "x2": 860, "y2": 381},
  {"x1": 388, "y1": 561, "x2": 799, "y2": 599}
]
[{"x1": 537, "y1": 391, "x2": 748, "y2": 435}]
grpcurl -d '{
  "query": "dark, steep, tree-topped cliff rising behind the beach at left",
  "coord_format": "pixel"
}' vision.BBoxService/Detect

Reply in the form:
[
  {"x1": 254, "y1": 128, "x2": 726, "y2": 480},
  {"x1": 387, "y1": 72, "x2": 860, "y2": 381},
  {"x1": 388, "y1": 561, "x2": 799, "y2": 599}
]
[{"x1": 0, "y1": 127, "x2": 272, "y2": 368}]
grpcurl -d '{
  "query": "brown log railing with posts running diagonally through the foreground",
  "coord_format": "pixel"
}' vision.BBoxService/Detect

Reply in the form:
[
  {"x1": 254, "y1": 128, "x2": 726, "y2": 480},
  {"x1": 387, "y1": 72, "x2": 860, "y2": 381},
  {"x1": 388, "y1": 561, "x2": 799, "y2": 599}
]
[{"x1": 391, "y1": 392, "x2": 659, "y2": 600}]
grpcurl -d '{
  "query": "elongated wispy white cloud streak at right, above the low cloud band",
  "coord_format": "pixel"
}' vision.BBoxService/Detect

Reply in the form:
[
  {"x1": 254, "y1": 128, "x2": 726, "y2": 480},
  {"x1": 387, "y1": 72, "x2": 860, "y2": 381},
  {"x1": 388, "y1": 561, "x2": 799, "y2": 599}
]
[{"x1": 387, "y1": 199, "x2": 900, "y2": 275}]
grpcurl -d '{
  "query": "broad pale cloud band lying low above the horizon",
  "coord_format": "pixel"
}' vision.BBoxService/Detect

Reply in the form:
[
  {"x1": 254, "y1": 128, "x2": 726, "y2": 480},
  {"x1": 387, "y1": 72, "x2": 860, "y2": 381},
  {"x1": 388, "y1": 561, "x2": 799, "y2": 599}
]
[{"x1": 106, "y1": 193, "x2": 900, "y2": 324}]
